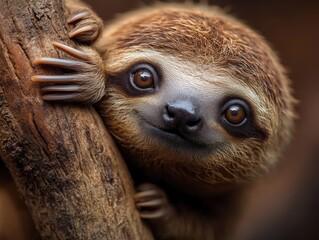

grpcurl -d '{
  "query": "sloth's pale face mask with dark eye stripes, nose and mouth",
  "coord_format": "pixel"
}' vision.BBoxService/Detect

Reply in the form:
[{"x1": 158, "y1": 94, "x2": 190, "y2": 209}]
[{"x1": 105, "y1": 51, "x2": 268, "y2": 156}]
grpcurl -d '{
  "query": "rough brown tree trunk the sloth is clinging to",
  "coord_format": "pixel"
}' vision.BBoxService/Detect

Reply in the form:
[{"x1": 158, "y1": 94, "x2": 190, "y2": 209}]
[{"x1": 0, "y1": 0, "x2": 152, "y2": 240}]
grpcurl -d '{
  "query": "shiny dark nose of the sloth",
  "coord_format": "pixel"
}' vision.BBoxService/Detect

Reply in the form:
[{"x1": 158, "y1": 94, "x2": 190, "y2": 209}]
[{"x1": 163, "y1": 101, "x2": 203, "y2": 135}]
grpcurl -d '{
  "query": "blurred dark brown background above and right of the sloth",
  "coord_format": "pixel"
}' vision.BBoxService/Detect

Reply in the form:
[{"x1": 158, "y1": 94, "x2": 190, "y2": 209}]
[{"x1": 87, "y1": 0, "x2": 319, "y2": 240}]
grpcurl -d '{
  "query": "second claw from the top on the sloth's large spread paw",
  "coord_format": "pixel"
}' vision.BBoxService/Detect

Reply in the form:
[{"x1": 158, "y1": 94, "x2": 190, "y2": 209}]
[{"x1": 34, "y1": 57, "x2": 89, "y2": 70}]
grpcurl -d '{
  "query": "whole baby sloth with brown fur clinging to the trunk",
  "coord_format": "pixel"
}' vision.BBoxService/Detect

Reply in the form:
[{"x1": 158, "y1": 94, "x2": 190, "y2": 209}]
[{"x1": 32, "y1": 1, "x2": 294, "y2": 240}]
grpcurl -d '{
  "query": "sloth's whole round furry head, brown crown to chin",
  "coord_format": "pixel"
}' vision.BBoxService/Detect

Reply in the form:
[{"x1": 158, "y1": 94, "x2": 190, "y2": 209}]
[{"x1": 96, "y1": 5, "x2": 293, "y2": 191}]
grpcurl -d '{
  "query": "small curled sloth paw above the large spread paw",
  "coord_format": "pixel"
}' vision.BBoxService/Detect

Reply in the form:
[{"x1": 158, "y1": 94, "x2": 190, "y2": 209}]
[{"x1": 67, "y1": 8, "x2": 103, "y2": 43}]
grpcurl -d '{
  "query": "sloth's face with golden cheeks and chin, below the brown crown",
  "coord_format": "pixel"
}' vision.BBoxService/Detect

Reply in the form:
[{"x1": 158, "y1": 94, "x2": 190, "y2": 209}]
[{"x1": 100, "y1": 50, "x2": 277, "y2": 189}]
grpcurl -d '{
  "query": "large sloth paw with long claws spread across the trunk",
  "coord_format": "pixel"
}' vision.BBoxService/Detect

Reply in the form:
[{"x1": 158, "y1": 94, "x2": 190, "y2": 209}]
[{"x1": 31, "y1": 42, "x2": 105, "y2": 104}]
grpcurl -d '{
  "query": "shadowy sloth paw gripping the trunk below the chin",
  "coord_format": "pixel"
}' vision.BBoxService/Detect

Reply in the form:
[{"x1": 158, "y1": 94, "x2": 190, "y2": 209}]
[{"x1": 134, "y1": 183, "x2": 170, "y2": 219}]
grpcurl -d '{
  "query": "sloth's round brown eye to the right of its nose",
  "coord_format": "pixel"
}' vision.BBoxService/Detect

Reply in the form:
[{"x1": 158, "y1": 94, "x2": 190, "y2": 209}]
[{"x1": 222, "y1": 99, "x2": 250, "y2": 127}]
